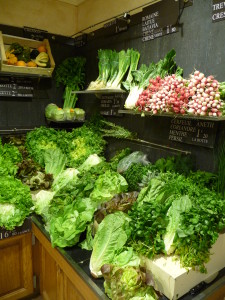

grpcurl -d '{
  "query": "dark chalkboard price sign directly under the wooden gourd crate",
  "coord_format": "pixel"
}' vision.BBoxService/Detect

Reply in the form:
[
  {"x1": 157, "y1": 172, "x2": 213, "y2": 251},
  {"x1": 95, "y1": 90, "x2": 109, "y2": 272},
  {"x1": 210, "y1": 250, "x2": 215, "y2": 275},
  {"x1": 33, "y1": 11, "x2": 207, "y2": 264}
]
[{"x1": 0, "y1": 76, "x2": 34, "y2": 97}]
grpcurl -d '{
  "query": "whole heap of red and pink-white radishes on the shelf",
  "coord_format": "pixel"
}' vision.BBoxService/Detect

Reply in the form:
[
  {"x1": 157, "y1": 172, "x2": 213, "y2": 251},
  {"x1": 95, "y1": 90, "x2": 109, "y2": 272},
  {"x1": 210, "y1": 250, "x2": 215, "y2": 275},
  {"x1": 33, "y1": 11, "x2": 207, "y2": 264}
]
[{"x1": 135, "y1": 71, "x2": 225, "y2": 117}]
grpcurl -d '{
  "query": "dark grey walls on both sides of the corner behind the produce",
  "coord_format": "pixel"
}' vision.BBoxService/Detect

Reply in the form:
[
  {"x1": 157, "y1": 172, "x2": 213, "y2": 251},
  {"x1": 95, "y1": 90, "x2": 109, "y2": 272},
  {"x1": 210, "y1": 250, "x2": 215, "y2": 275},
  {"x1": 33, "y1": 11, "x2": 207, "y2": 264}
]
[{"x1": 0, "y1": 0, "x2": 225, "y2": 171}]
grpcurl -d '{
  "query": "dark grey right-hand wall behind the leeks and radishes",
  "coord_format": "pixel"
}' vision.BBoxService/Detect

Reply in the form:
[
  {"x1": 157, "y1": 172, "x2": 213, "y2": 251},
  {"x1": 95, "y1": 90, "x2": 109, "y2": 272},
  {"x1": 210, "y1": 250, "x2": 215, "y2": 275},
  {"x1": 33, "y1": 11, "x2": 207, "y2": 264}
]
[{"x1": 74, "y1": 0, "x2": 225, "y2": 171}]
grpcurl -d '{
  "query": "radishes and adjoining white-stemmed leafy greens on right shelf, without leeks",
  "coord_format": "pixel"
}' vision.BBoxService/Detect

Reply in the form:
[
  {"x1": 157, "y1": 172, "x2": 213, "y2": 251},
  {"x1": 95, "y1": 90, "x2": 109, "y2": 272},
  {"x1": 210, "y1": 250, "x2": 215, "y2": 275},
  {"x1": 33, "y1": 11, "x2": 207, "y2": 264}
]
[{"x1": 124, "y1": 49, "x2": 225, "y2": 117}]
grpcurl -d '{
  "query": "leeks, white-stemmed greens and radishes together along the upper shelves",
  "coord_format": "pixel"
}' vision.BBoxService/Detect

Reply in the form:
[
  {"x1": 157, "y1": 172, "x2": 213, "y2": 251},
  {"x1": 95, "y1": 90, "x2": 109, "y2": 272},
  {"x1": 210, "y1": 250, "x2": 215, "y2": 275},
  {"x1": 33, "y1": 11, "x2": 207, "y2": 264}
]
[{"x1": 83, "y1": 49, "x2": 225, "y2": 117}]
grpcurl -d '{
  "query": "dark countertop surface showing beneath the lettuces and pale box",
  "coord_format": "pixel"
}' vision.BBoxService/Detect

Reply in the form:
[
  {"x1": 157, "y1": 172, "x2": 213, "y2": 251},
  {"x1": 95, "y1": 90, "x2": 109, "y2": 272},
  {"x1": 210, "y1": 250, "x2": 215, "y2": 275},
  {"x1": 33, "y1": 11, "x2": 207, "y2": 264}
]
[{"x1": 32, "y1": 215, "x2": 225, "y2": 300}]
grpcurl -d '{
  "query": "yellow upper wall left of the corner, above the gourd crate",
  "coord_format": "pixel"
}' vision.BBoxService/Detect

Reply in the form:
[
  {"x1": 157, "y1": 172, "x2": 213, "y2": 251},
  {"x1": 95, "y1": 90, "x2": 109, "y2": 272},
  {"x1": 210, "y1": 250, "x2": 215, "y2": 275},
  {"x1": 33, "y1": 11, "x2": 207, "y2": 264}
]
[{"x1": 0, "y1": 0, "x2": 77, "y2": 36}]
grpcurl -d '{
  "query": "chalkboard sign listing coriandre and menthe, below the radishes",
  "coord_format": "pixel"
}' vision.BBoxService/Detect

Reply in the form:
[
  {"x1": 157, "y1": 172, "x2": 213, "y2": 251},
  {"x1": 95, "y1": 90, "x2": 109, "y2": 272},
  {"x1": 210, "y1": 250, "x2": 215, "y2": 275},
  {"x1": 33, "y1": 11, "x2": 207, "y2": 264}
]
[{"x1": 168, "y1": 118, "x2": 217, "y2": 148}]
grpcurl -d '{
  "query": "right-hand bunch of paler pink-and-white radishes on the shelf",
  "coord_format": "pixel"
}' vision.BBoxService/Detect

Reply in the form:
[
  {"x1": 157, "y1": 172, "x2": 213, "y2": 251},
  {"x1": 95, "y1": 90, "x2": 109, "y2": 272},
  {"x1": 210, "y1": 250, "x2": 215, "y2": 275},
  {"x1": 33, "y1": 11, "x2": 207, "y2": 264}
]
[{"x1": 187, "y1": 71, "x2": 223, "y2": 117}]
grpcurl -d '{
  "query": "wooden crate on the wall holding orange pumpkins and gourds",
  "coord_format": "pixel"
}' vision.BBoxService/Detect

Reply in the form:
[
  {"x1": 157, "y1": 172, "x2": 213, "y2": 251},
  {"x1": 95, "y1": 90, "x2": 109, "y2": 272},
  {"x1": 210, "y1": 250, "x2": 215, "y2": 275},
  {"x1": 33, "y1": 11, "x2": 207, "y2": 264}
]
[{"x1": 0, "y1": 31, "x2": 55, "y2": 77}]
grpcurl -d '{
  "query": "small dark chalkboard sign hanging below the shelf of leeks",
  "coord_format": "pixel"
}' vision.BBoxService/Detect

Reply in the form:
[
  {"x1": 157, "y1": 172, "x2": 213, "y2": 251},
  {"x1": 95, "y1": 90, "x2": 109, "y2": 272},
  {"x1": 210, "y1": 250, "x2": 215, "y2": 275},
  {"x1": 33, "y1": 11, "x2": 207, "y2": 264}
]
[{"x1": 100, "y1": 93, "x2": 127, "y2": 116}]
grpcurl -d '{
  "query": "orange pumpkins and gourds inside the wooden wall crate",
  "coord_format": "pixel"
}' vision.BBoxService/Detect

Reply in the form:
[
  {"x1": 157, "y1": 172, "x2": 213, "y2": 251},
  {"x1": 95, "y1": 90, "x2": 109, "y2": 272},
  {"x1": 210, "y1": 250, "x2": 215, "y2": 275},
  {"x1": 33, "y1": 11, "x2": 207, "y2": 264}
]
[{"x1": 5, "y1": 43, "x2": 50, "y2": 68}]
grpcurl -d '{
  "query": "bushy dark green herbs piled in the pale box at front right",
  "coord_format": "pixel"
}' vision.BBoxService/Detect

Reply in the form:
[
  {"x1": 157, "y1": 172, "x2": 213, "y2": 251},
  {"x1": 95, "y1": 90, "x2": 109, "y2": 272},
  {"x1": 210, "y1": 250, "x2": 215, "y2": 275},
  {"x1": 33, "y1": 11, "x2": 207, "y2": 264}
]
[{"x1": 129, "y1": 173, "x2": 225, "y2": 272}]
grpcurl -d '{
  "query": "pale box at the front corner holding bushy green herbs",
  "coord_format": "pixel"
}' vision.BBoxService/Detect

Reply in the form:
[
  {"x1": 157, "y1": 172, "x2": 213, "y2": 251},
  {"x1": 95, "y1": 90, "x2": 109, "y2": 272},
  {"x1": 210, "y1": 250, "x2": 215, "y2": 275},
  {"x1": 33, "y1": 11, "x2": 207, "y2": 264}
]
[{"x1": 146, "y1": 234, "x2": 225, "y2": 300}]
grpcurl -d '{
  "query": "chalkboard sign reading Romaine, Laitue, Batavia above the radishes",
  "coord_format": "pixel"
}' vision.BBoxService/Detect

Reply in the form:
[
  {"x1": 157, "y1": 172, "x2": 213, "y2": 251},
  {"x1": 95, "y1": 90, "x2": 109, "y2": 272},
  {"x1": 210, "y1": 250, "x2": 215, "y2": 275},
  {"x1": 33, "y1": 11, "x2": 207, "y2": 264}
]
[{"x1": 142, "y1": 0, "x2": 179, "y2": 42}]
